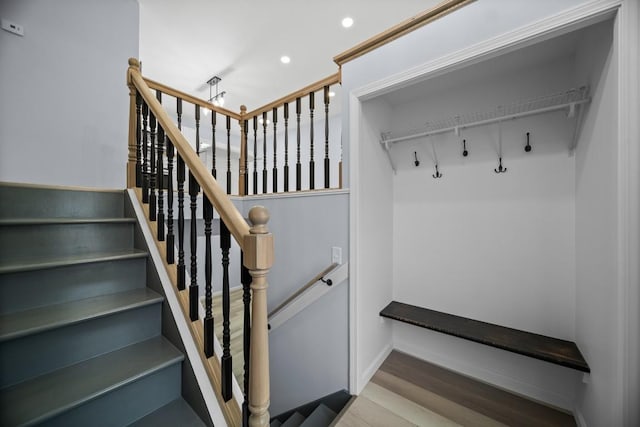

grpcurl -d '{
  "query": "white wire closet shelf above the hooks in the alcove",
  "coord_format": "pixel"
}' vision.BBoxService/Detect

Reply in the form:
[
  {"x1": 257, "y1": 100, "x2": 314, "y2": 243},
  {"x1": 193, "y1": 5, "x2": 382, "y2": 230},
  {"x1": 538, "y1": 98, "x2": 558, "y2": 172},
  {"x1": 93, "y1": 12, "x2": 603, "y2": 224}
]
[{"x1": 380, "y1": 86, "x2": 591, "y2": 146}]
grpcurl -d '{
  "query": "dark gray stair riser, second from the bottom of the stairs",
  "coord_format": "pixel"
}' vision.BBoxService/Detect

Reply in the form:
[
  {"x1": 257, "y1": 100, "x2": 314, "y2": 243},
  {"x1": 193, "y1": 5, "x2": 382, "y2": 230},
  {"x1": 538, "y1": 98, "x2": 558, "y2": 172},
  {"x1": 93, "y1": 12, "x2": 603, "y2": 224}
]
[{"x1": 0, "y1": 303, "x2": 162, "y2": 388}]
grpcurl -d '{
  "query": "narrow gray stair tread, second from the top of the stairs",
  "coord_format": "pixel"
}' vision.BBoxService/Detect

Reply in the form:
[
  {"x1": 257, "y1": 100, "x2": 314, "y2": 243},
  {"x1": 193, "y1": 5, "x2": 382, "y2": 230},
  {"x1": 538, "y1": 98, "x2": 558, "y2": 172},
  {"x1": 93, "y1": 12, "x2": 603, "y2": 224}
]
[{"x1": 0, "y1": 249, "x2": 148, "y2": 274}]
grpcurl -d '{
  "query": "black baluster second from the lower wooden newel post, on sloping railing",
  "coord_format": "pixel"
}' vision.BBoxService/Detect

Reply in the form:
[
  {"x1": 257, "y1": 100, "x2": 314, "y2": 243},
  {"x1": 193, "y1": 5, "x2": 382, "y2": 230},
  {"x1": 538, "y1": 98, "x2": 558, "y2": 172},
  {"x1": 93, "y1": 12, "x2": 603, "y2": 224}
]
[{"x1": 220, "y1": 220, "x2": 233, "y2": 402}]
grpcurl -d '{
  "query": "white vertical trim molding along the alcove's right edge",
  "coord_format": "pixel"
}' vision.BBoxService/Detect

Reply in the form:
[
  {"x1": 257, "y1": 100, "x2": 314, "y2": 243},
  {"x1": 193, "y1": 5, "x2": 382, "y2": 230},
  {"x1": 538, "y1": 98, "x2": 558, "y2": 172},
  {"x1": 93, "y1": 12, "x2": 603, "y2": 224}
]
[{"x1": 617, "y1": 0, "x2": 640, "y2": 426}]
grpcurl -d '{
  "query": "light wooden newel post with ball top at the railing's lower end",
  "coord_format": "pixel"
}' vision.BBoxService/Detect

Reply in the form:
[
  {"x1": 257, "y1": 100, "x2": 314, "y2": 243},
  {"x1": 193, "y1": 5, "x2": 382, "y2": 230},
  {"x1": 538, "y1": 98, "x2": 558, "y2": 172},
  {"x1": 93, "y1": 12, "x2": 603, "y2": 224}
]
[{"x1": 244, "y1": 206, "x2": 273, "y2": 427}]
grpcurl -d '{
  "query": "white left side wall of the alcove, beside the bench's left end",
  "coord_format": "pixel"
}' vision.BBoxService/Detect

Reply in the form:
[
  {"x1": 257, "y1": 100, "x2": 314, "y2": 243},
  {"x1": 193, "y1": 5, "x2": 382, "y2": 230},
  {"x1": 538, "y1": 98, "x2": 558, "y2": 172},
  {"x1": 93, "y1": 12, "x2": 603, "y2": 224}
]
[{"x1": 350, "y1": 98, "x2": 393, "y2": 393}]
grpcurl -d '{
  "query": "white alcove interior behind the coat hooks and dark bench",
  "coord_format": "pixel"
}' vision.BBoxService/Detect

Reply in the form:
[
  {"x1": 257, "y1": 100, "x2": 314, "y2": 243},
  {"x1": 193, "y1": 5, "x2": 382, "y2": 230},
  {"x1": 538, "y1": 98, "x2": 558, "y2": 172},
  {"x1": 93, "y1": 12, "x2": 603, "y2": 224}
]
[{"x1": 360, "y1": 15, "x2": 617, "y2": 408}]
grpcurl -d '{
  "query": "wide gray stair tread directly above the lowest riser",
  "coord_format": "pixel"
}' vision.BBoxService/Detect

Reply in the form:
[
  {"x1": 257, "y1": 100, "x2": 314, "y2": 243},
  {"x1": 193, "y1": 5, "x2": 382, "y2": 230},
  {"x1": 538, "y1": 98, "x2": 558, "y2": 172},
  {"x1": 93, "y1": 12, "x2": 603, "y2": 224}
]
[{"x1": 0, "y1": 336, "x2": 184, "y2": 425}]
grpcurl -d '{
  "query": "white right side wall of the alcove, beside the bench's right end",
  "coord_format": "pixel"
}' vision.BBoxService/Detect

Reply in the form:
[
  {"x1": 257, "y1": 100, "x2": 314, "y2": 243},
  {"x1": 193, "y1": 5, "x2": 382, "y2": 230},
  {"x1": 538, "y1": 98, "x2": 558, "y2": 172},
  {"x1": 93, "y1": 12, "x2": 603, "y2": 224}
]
[{"x1": 575, "y1": 17, "x2": 620, "y2": 426}]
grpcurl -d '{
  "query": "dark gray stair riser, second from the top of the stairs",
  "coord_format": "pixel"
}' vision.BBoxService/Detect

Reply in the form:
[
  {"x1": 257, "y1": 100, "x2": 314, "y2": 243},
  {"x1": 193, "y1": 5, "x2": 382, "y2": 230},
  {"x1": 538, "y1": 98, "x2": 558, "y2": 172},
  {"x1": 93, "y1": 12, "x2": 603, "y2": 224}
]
[{"x1": 0, "y1": 223, "x2": 133, "y2": 264}]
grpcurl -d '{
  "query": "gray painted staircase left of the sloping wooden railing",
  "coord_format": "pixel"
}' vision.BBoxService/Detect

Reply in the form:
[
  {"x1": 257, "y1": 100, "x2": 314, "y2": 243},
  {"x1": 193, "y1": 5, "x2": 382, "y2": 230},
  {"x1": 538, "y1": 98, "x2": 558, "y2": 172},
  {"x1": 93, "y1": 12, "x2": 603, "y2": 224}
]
[{"x1": 0, "y1": 184, "x2": 205, "y2": 426}]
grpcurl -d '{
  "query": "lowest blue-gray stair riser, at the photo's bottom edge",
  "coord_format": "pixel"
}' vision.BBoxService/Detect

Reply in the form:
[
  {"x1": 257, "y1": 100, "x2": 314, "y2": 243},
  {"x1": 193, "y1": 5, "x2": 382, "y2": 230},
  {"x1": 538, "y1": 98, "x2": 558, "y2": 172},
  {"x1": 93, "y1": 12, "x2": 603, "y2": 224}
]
[{"x1": 39, "y1": 363, "x2": 181, "y2": 427}]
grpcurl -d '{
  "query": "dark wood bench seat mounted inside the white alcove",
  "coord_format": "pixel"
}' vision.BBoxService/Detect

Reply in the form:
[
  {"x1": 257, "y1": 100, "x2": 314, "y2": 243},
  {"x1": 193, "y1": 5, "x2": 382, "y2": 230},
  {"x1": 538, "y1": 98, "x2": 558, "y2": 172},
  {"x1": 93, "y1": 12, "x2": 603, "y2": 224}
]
[{"x1": 380, "y1": 301, "x2": 591, "y2": 372}]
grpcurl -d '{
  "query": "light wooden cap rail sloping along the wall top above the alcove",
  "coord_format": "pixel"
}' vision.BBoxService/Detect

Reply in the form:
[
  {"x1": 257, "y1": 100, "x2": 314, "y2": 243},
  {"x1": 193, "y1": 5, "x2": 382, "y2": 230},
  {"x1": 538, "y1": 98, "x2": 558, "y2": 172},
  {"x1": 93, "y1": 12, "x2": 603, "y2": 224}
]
[{"x1": 333, "y1": 0, "x2": 474, "y2": 66}]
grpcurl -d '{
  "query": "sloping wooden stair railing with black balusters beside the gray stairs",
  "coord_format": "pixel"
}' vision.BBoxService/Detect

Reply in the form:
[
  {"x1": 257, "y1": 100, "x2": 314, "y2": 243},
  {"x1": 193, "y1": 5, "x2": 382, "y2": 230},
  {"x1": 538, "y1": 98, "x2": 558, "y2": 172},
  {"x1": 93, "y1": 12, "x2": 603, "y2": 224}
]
[{"x1": 127, "y1": 58, "x2": 273, "y2": 426}]
